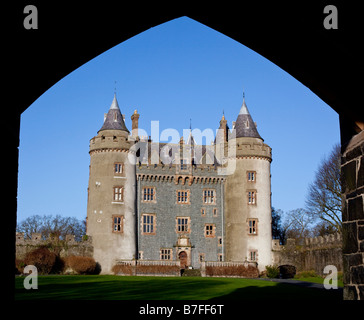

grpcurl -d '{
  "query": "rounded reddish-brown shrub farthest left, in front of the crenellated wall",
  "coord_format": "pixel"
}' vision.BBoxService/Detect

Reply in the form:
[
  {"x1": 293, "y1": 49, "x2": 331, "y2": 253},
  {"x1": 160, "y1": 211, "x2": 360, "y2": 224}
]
[{"x1": 24, "y1": 247, "x2": 56, "y2": 274}]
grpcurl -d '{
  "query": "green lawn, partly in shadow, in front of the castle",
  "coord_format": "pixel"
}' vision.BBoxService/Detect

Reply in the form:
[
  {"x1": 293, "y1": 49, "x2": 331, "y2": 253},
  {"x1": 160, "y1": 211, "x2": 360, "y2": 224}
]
[{"x1": 15, "y1": 275, "x2": 342, "y2": 300}]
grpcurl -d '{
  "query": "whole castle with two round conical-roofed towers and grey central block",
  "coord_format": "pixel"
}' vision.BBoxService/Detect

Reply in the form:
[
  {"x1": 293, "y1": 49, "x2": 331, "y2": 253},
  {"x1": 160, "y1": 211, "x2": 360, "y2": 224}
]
[{"x1": 87, "y1": 95, "x2": 272, "y2": 273}]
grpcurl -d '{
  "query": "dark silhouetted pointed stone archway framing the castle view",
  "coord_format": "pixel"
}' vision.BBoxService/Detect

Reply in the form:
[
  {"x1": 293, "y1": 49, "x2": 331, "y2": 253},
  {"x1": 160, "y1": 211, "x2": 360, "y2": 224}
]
[{"x1": 9, "y1": 1, "x2": 364, "y2": 299}]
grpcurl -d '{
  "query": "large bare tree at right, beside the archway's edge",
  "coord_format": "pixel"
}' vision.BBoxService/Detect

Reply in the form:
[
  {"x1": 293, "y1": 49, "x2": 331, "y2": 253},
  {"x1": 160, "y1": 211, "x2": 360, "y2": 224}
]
[{"x1": 306, "y1": 144, "x2": 342, "y2": 232}]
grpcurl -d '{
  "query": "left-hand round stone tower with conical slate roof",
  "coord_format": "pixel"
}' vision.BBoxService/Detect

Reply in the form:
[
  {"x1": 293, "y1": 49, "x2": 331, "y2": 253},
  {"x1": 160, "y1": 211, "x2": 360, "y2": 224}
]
[{"x1": 87, "y1": 95, "x2": 137, "y2": 273}]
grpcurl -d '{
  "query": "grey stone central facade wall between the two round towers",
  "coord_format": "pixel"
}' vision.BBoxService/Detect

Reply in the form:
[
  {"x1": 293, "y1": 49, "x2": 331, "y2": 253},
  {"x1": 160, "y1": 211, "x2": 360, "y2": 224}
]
[{"x1": 137, "y1": 166, "x2": 223, "y2": 268}]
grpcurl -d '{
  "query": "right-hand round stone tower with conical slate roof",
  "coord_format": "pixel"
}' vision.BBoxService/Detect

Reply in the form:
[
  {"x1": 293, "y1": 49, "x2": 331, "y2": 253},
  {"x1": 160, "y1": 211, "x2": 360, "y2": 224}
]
[{"x1": 224, "y1": 98, "x2": 272, "y2": 271}]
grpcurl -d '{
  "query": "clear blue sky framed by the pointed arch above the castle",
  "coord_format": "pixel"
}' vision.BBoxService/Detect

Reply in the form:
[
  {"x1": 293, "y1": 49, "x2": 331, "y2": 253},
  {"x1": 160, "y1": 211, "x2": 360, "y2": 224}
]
[{"x1": 18, "y1": 17, "x2": 340, "y2": 221}]
